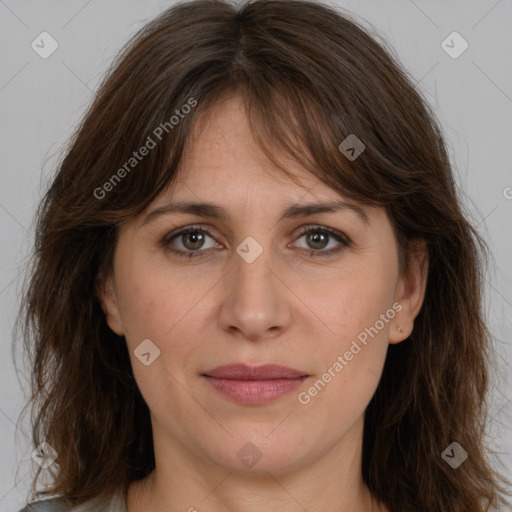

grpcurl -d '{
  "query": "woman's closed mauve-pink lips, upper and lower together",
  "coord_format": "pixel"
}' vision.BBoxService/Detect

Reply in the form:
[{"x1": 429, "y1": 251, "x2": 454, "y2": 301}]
[{"x1": 202, "y1": 364, "x2": 309, "y2": 405}]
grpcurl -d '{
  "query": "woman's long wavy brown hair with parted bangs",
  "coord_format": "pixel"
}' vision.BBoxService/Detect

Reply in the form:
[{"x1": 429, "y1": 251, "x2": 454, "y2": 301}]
[{"x1": 15, "y1": 0, "x2": 508, "y2": 512}]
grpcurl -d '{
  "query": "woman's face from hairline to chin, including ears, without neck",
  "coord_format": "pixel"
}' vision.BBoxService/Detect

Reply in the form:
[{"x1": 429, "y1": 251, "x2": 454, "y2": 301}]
[{"x1": 99, "y1": 93, "x2": 425, "y2": 473}]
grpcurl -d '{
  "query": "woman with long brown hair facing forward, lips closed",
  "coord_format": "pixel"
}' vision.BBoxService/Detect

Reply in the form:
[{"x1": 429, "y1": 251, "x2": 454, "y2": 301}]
[{"x1": 13, "y1": 0, "x2": 506, "y2": 512}]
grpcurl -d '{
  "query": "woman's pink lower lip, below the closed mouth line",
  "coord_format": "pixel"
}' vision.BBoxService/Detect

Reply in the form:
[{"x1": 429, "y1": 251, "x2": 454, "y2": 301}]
[{"x1": 204, "y1": 375, "x2": 307, "y2": 405}]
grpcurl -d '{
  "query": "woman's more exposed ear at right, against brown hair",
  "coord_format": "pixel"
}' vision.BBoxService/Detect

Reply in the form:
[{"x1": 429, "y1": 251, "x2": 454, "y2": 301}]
[{"x1": 389, "y1": 239, "x2": 429, "y2": 344}]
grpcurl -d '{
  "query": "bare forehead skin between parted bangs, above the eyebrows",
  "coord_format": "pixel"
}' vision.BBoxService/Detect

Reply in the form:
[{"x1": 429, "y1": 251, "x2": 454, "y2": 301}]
[{"x1": 172, "y1": 96, "x2": 328, "y2": 199}]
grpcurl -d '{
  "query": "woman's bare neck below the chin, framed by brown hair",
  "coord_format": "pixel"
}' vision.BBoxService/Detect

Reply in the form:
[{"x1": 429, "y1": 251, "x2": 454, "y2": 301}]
[{"x1": 127, "y1": 416, "x2": 389, "y2": 512}]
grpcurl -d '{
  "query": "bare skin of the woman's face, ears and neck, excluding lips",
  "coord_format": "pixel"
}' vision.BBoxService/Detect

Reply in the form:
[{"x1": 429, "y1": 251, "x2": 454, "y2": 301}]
[{"x1": 99, "y1": 96, "x2": 427, "y2": 512}]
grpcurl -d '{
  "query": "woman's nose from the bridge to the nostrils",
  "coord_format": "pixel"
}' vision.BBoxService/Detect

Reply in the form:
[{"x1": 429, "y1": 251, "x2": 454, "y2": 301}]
[{"x1": 219, "y1": 240, "x2": 294, "y2": 341}]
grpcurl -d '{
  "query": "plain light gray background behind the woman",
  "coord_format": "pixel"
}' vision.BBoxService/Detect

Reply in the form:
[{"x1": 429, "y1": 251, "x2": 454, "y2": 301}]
[{"x1": 0, "y1": 0, "x2": 512, "y2": 512}]
